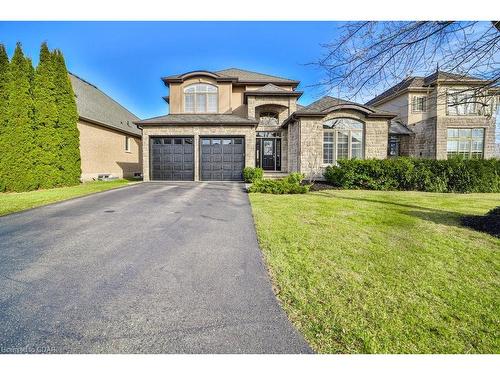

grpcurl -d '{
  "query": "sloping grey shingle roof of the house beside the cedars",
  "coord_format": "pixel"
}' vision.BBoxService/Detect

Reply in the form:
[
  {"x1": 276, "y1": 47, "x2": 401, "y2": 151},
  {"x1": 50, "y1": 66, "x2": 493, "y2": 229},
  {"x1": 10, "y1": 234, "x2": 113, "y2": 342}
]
[{"x1": 69, "y1": 73, "x2": 142, "y2": 136}]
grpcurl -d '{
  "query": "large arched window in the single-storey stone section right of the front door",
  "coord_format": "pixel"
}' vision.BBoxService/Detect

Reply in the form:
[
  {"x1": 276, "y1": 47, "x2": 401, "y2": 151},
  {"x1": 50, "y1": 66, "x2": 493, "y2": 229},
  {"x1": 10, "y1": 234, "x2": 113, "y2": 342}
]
[{"x1": 323, "y1": 118, "x2": 364, "y2": 164}]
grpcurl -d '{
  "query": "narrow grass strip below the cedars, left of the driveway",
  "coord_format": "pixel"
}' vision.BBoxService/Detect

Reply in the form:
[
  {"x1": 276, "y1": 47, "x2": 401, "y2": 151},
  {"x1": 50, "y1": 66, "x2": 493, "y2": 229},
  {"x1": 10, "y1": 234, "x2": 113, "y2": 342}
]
[{"x1": 0, "y1": 180, "x2": 133, "y2": 216}]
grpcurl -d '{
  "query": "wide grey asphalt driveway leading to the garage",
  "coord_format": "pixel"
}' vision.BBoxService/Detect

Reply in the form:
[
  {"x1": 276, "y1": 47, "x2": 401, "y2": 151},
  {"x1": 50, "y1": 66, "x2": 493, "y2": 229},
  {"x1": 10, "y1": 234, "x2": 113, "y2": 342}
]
[{"x1": 0, "y1": 183, "x2": 310, "y2": 353}]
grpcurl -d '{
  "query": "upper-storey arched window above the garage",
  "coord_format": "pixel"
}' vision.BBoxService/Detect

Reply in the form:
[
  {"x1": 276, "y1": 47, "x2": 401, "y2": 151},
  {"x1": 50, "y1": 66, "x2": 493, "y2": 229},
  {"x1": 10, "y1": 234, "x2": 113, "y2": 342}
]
[{"x1": 184, "y1": 83, "x2": 219, "y2": 113}]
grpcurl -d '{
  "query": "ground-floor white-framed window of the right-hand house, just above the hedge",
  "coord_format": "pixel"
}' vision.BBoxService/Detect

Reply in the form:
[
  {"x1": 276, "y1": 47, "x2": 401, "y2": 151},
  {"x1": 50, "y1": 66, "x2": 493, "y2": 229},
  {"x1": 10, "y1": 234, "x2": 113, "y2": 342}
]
[{"x1": 447, "y1": 128, "x2": 484, "y2": 159}]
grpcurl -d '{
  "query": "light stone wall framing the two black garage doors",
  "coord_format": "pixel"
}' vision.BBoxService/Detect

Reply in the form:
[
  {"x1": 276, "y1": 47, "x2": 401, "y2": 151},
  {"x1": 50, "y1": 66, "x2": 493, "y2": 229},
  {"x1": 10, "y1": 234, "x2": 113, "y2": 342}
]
[{"x1": 142, "y1": 125, "x2": 256, "y2": 181}]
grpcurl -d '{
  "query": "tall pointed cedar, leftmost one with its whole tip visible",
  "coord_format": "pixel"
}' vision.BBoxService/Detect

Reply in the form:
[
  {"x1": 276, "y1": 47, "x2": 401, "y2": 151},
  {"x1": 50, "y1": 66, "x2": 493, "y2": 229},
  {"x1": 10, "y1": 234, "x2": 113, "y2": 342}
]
[{"x1": 0, "y1": 43, "x2": 37, "y2": 191}]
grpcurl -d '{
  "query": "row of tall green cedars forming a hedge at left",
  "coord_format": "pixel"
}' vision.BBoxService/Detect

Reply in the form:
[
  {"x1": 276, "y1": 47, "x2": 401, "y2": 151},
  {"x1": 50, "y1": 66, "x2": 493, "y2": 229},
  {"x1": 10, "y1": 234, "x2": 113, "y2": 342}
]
[{"x1": 0, "y1": 43, "x2": 81, "y2": 192}]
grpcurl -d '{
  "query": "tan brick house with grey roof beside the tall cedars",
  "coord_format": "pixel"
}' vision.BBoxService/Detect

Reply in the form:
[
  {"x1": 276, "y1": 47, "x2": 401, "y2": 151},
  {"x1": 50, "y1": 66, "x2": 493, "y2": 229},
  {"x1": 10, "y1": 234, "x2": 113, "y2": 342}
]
[{"x1": 70, "y1": 74, "x2": 142, "y2": 181}]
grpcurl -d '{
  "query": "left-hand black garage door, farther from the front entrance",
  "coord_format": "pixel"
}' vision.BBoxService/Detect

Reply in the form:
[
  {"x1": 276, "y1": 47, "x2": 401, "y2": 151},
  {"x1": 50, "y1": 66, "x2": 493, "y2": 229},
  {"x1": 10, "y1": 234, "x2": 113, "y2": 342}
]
[{"x1": 150, "y1": 137, "x2": 194, "y2": 181}]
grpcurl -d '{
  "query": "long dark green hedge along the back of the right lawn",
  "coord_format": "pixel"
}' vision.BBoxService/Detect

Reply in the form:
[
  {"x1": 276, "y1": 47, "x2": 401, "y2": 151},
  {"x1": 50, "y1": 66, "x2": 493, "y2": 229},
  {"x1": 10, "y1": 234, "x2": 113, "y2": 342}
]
[{"x1": 324, "y1": 157, "x2": 500, "y2": 193}]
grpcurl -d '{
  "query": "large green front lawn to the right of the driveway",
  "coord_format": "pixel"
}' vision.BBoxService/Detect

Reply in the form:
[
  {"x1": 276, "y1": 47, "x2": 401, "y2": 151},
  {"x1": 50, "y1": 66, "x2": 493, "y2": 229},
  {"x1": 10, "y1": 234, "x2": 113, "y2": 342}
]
[{"x1": 250, "y1": 190, "x2": 500, "y2": 353}]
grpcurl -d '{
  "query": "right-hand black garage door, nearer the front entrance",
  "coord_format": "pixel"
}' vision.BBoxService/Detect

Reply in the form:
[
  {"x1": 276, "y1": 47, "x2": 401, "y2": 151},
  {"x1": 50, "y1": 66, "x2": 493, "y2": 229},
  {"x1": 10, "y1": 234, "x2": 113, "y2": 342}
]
[{"x1": 200, "y1": 137, "x2": 245, "y2": 181}]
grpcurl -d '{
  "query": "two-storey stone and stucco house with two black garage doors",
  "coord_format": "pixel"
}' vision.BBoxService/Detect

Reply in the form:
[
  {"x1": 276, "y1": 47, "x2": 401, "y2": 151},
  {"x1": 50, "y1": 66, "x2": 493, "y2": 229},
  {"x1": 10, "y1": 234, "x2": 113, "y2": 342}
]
[{"x1": 136, "y1": 68, "x2": 396, "y2": 181}]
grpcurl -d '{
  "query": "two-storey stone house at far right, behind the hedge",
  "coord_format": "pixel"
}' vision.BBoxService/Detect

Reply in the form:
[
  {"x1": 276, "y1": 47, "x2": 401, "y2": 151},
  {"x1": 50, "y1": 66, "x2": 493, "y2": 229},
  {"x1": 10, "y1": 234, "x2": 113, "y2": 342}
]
[{"x1": 367, "y1": 71, "x2": 498, "y2": 159}]
